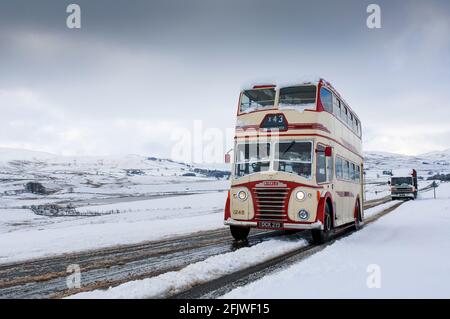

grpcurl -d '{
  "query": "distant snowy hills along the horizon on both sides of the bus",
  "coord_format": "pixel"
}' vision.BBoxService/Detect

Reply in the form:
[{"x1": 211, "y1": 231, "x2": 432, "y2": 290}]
[{"x1": 0, "y1": 148, "x2": 450, "y2": 178}]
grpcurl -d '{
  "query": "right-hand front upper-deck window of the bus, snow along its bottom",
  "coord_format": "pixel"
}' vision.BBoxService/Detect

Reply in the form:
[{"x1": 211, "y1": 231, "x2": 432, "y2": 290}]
[{"x1": 278, "y1": 85, "x2": 316, "y2": 110}]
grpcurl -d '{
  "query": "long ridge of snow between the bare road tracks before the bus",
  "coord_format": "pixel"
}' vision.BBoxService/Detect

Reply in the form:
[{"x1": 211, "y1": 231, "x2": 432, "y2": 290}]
[{"x1": 70, "y1": 239, "x2": 307, "y2": 299}]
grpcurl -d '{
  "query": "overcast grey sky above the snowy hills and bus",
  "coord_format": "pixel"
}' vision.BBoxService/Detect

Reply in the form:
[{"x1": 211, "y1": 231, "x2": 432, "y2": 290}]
[{"x1": 0, "y1": 0, "x2": 450, "y2": 160}]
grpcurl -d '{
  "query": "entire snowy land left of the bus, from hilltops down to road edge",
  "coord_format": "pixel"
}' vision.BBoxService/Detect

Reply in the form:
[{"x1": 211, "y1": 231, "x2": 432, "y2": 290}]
[{"x1": 0, "y1": 148, "x2": 229, "y2": 263}]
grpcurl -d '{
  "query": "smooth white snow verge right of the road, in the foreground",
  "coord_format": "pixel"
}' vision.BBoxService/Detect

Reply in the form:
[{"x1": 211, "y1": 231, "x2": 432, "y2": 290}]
[{"x1": 224, "y1": 183, "x2": 450, "y2": 298}]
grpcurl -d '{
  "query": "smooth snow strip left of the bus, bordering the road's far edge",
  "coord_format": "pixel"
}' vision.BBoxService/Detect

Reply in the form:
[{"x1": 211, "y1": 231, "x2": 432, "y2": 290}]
[{"x1": 0, "y1": 192, "x2": 227, "y2": 263}]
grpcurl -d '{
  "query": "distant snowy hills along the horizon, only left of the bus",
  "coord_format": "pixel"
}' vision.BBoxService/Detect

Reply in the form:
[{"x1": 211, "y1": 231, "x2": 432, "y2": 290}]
[{"x1": 0, "y1": 148, "x2": 229, "y2": 182}]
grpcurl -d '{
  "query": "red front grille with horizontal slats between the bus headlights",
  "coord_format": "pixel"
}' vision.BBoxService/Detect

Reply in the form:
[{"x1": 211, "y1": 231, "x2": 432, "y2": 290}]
[{"x1": 253, "y1": 187, "x2": 289, "y2": 221}]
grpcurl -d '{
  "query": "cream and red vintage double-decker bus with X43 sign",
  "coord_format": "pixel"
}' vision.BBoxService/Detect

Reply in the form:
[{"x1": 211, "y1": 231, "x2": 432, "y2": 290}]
[{"x1": 224, "y1": 79, "x2": 364, "y2": 243}]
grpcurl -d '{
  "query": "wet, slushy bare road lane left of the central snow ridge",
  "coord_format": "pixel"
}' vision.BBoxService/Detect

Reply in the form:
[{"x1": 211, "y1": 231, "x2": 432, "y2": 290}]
[{"x1": 0, "y1": 228, "x2": 281, "y2": 298}]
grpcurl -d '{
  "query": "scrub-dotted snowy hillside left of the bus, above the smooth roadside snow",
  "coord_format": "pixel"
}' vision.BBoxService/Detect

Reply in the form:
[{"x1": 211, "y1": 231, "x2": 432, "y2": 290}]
[{"x1": 0, "y1": 148, "x2": 228, "y2": 208}]
